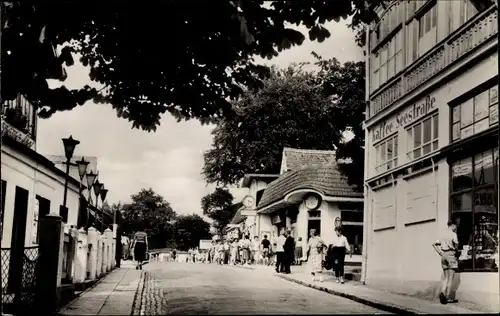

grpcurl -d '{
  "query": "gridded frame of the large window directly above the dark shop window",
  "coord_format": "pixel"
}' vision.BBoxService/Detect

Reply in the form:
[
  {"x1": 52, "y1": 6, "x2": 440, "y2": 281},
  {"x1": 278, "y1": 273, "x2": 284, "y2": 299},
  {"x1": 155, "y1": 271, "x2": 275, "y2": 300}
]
[{"x1": 449, "y1": 84, "x2": 498, "y2": 144}]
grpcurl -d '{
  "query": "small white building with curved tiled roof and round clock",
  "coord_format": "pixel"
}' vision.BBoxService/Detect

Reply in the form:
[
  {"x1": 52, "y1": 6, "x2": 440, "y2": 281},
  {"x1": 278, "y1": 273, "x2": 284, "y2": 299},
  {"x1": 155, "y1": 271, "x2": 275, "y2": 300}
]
[{"x1": 242, "y1": 148, "x2": 363, "y2": 253}]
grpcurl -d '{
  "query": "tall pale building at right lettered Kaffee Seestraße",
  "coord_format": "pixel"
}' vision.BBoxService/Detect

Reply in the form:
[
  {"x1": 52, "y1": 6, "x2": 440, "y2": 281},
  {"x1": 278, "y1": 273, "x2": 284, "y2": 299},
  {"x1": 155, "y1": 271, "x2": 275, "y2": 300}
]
[{"x1": 363, "y1": 0, "x2": 500, "y2": 310}]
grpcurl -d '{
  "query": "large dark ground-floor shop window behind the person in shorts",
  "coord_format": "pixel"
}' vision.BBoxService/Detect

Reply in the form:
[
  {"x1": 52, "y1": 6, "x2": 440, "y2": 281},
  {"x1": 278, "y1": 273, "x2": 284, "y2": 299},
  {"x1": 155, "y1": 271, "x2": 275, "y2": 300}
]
[{"x1": 450, "y1": 148, "x2": 498, "y2": 271}]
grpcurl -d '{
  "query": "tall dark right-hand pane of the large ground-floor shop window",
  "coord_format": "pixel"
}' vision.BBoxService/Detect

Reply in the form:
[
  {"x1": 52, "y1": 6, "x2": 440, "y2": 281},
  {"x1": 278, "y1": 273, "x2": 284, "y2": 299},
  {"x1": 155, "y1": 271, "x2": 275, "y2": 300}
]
[{"x1": 473, "y1": 187, "x2": 498, "y2": 271}]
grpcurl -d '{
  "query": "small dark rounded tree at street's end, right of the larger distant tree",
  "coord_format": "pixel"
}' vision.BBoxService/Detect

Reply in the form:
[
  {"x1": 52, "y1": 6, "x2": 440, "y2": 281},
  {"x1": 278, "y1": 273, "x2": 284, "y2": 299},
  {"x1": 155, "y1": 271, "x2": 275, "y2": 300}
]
[{"x1": 174, "y1": 214, "x2": 211, "y2": 251}]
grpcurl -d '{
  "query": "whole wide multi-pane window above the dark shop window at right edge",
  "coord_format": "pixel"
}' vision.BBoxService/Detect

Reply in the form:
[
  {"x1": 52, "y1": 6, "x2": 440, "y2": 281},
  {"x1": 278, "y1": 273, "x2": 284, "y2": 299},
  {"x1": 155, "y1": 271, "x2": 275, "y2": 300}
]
[{"x1": 452, "y1": 86, "x2": 498, "y2": 141}]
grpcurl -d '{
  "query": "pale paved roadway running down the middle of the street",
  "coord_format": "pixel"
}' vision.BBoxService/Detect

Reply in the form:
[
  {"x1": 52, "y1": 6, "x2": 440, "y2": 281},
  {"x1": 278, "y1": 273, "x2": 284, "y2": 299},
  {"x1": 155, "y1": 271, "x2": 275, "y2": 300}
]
[{"x1": 141, "y1": 263, "x2": 384, "y2": 315}]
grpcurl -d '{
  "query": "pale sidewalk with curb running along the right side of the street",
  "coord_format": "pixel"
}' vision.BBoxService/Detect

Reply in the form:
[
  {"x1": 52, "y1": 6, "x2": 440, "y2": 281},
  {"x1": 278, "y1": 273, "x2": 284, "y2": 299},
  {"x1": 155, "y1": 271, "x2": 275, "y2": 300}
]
[{"x1": 275, "y1": 272, "x2": 480, "y2": 314}]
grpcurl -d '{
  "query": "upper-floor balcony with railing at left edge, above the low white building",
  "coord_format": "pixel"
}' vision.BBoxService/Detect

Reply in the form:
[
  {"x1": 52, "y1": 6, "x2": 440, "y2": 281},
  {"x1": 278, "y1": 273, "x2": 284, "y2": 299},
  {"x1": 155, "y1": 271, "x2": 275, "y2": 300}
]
[{"x1": 1, "y1": 95, "x2": 37, "y2": 149}]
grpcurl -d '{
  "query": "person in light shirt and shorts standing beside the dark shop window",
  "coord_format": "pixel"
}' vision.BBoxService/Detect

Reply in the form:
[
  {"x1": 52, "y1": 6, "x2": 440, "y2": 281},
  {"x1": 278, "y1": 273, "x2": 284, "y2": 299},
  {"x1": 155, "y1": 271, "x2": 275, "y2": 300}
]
[{"x1": 432, "y1": 221, "x2": 458, "y2": 304}]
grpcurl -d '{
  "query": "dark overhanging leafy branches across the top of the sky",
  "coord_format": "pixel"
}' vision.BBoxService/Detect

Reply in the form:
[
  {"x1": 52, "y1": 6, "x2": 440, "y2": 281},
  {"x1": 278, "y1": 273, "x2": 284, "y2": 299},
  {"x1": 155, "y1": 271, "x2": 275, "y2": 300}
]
[{"x1": 1, "y1": 0, "x2": 381, "y2": 131}]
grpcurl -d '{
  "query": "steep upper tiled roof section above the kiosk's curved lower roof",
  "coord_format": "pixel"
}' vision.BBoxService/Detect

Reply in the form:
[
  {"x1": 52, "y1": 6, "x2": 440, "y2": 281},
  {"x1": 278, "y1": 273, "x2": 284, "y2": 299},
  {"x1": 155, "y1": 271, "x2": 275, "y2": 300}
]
[{"x1": 283, "y1": 147, "x2": 335, "y2": 171}]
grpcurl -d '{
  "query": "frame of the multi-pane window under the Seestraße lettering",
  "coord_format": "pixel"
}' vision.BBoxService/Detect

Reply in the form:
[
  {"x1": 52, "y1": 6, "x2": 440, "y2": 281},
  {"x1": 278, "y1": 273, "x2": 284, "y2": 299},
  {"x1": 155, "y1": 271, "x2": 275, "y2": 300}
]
[{"x1": 405, "y1": 111, "x2": 439, "y2": 161}]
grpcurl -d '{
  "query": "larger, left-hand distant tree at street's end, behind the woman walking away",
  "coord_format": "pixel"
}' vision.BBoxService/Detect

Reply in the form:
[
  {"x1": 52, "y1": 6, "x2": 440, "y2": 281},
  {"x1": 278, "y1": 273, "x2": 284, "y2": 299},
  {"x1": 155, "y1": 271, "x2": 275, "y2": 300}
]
[{"x1": 122, "y1": 188, "x2": 176, "y2": 249}]
